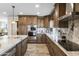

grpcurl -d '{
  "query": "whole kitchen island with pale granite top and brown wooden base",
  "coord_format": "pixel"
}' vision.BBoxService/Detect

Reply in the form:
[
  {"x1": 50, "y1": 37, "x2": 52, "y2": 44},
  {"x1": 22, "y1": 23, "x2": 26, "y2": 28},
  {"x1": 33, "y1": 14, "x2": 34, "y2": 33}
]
[{"x1": 0, "y1": 35, "x2": 27, "y2": 56}]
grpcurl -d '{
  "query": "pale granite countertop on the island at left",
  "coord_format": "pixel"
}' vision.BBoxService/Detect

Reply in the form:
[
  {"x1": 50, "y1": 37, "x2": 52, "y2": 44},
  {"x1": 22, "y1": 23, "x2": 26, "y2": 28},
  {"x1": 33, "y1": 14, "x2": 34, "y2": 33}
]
[{"x1": 0, "y1": 35, "x2": 27, "y2": 55}]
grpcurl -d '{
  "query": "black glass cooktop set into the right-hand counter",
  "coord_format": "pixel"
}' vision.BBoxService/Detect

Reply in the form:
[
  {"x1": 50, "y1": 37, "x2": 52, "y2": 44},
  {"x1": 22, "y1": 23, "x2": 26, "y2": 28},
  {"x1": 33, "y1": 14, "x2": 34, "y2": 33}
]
[{"x1": 58, "y1": 40, "x2": 79, "y2": 51}]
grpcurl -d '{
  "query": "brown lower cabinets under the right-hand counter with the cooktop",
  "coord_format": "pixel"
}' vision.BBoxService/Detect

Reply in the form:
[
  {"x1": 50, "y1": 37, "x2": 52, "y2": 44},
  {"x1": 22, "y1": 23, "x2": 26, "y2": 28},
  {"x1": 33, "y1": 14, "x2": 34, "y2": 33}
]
[{"x1": 46, "y1": 36, "x2": 66, "y2": 56}]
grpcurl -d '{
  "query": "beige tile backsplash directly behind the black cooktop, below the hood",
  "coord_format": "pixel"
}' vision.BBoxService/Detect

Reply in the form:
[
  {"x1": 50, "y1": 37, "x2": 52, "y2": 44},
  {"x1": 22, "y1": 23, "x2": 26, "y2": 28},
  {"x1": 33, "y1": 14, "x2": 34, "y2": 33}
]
[{"x1": 67, "y1": 19, "x2": 79, "y2": 44}]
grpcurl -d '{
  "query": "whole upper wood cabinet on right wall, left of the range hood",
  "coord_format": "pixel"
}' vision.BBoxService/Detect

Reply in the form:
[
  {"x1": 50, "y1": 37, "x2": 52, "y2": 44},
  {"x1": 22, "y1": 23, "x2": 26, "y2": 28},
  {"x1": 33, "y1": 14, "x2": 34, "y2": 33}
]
[{"x1": 51, "y1": 3, "x2": 69, "y2": 28}]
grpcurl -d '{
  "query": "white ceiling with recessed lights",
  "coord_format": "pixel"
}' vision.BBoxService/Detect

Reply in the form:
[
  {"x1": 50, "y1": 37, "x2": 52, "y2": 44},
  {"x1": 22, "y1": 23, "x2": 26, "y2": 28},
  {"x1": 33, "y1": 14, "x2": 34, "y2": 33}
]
[{"x1": 0, "y1": 3, "x2": 54, "y2": 16}]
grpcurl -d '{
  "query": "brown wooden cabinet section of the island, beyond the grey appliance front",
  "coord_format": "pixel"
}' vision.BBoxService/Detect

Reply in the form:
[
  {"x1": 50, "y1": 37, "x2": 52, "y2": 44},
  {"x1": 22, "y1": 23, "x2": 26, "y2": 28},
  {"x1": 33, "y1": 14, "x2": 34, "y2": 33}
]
[{"x1": 15, "y1": 39, "x2": 27, "y2": 56}]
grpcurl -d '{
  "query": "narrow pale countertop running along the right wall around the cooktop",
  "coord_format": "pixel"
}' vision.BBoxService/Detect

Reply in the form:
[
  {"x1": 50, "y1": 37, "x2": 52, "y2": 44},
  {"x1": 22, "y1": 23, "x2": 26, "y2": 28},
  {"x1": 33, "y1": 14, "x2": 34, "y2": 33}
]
[{"x1": 45, "y1": 33, "x2": 79, "y2": 56}]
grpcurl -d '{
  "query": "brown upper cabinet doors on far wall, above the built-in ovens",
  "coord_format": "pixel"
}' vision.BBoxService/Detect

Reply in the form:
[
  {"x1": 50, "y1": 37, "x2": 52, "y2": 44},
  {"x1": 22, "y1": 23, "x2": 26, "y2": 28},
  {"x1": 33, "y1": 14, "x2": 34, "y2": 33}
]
[{"x1": 18, "y1": 16, "x2": 37, "y2": 25}]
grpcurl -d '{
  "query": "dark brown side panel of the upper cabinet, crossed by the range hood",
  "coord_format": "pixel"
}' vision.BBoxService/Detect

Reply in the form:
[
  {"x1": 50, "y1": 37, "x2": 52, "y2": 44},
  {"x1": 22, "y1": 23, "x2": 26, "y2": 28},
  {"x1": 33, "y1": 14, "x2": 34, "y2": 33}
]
[{"x1": 58, "y1": 3, "x2": 68, "y2": 28}]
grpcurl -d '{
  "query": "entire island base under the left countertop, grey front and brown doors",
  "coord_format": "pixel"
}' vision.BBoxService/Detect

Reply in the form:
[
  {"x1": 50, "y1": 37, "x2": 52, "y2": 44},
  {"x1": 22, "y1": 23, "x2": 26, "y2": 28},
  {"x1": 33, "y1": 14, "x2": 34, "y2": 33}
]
[{"x1": 2, "y1": 39, "x2": 27, "y2": 56}]
